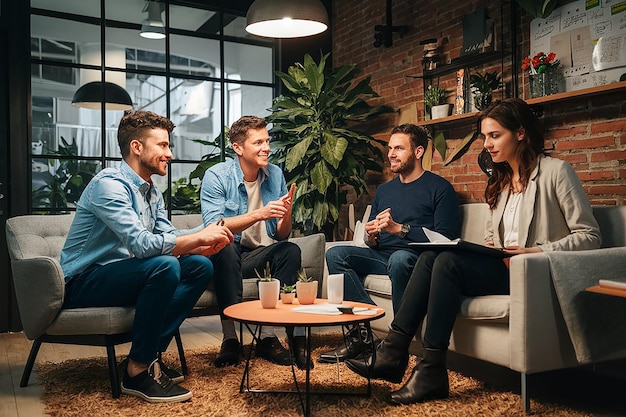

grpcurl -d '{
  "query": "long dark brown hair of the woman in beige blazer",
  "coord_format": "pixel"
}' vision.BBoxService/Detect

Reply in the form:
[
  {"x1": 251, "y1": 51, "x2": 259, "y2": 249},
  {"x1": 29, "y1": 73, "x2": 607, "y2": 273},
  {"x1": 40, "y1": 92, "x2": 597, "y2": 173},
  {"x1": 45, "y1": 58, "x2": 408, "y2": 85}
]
[{"x1": 477, "y1": 98, "x2": 544, "y2": 208}]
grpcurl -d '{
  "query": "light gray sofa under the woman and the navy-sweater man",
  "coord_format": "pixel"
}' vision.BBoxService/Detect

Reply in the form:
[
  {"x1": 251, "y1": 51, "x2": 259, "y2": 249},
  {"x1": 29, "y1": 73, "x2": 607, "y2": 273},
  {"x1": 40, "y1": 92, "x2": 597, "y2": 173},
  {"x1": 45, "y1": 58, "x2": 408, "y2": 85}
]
[{"x1": 327, "y1": 203, "x2": 626, "y2": 411}]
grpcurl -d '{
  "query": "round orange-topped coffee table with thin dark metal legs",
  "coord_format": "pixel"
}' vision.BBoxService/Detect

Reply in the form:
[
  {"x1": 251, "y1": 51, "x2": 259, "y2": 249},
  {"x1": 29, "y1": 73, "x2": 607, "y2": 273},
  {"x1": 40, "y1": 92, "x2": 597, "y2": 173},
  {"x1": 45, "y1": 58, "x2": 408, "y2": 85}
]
[{"x1": 224, "y1": 299, "x2": 385, "y2": 417}]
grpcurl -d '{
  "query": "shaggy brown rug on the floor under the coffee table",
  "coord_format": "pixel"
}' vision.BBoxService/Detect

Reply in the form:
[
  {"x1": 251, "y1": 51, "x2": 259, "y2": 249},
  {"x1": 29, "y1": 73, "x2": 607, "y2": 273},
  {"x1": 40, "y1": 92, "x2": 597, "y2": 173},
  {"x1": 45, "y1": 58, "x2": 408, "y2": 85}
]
[{"x1": 38, "y1": 335, "x2": 589, "y2": 417}]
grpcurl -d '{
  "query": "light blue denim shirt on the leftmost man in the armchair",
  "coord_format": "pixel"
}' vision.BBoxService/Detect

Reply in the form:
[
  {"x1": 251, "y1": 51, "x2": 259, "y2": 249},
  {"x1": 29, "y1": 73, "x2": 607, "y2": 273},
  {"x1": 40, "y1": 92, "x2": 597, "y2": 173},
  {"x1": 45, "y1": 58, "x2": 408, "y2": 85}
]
[{"x1": 61, "y1": 161, "x2": 180, "y2": 282}]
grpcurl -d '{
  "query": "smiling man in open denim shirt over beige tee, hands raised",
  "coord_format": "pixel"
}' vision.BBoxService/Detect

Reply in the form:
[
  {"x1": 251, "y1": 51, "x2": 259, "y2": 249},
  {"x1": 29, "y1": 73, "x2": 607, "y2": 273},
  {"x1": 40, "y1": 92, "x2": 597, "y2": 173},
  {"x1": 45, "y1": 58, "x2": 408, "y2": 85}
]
[{"x1": 200, "y1": 116, "x2": 307, "y2": 368}]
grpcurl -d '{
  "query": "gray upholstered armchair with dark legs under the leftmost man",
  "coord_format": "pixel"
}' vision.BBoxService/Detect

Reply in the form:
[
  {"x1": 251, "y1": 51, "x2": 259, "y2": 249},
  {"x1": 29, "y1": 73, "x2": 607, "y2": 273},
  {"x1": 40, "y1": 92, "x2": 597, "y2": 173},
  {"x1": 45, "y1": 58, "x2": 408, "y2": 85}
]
[{"x1": 6, "y1": 215, "x2": 135, "y2": 398}]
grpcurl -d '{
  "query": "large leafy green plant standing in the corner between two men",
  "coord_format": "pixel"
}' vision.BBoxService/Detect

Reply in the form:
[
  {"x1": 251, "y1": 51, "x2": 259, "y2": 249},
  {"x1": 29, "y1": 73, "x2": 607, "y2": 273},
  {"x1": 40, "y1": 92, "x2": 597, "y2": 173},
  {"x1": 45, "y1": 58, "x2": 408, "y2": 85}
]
[{"x1": 266, "y1": 54, "x2": 392, "y2": 240}]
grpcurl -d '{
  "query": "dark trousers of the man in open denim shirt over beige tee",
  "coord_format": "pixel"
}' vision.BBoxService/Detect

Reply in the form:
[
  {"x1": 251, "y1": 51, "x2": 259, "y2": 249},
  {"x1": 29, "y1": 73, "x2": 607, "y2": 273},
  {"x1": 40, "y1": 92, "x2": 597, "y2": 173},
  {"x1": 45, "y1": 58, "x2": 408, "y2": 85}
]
[{"x1": 211, "y1": 240, "x2": 302, "y2": 319}]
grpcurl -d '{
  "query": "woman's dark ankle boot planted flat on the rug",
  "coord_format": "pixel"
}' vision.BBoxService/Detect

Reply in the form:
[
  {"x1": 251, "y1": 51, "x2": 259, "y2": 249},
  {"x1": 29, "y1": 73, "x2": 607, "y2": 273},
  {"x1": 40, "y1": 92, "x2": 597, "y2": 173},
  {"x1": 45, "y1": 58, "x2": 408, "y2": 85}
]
[{"x1": 388, "y1": 348, "x2": 450, "y2": 405}]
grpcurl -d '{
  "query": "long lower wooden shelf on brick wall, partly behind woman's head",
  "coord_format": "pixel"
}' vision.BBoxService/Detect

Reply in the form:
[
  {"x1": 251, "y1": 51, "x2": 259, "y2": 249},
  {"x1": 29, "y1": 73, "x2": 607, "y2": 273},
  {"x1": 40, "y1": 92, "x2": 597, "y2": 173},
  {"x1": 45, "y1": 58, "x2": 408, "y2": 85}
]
[{"x1": 417, "y1": 81, "x2": 626, "y2": 126}]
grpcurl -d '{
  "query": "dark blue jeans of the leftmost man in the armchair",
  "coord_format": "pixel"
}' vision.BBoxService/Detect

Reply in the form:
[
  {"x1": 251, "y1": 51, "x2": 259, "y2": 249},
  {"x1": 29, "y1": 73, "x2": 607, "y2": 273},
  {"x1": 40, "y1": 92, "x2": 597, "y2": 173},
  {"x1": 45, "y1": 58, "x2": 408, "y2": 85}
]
[{"x1": 63, "y1": 255, "x2": 213, "y2": 364}]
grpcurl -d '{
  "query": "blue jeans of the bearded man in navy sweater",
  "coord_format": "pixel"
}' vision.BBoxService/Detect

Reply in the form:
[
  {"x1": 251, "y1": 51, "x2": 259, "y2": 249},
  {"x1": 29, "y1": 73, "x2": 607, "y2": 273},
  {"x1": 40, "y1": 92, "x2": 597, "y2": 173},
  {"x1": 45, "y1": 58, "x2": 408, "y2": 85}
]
[{"x1": 326, "y1": 246, "x2": 419, "y2": 312}]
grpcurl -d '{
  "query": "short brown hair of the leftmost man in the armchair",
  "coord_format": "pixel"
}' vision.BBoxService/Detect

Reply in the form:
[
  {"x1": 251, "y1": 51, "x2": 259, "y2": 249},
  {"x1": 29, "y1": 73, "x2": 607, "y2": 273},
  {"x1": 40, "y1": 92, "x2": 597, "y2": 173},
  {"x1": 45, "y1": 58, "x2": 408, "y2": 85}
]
[{"x1": 117, "y1": 110, "x2": 175, "y2": 158}]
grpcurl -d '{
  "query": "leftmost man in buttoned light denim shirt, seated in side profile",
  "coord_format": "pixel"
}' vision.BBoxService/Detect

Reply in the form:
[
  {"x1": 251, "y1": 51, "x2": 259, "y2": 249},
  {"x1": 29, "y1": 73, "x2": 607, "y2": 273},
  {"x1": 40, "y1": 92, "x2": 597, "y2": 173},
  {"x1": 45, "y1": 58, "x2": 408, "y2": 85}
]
[{"x1": 61, "y1": 111, "x2": 233, "y2": 402}]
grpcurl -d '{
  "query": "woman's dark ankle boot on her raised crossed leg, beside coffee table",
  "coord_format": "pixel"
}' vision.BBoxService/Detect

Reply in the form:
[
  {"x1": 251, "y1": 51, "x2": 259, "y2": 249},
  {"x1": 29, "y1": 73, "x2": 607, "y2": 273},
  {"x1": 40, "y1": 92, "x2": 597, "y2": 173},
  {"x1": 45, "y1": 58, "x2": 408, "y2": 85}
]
[{"x1": 346, "y1": 330, "x2": 412, "y2": 383}]
